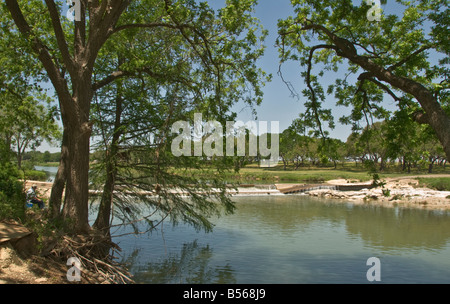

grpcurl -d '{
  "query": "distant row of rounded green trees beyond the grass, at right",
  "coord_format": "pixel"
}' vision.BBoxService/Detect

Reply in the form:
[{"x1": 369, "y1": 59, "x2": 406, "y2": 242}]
[{"x1": 280, "y1": 116, "x2": 447, "y2": 173}]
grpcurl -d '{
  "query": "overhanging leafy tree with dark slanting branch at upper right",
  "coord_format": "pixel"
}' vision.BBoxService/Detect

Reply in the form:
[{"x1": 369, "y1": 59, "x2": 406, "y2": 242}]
[{"x1": 278, "y1": 0, "x2": 450, "y2": 158}]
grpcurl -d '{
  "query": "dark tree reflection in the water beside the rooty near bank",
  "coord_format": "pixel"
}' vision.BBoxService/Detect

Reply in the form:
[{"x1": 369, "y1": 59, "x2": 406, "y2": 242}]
[{"x1": 125, "y1": 241, "x2": 236, "y2": 284}]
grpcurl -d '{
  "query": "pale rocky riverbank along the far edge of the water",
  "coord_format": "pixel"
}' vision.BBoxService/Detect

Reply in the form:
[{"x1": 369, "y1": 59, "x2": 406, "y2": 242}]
[{"x1": 26, "y1": 174, "x2": 450, "y2": 209}]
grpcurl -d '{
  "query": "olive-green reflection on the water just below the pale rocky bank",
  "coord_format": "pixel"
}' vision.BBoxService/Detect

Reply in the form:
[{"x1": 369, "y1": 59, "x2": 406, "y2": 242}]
[{"x1": 230, "y1": 196, "x2": 450, "y2": 250}]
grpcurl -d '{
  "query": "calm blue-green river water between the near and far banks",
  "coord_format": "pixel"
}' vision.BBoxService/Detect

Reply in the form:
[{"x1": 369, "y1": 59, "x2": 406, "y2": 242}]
[{"x1": 110, "y1": 195, "x2": 450, "y2": 284}]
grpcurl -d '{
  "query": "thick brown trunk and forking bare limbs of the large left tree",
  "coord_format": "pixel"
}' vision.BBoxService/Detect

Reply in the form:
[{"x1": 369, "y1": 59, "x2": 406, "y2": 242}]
[{"x1": 5, "y1": 0, "x2": 130, "y2": 233}]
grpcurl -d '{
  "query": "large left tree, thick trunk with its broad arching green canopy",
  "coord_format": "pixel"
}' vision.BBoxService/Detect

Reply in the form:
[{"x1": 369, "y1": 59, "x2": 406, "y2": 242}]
[{"x1": 1, "y1": 0, "x2": 266, "y2": 233}]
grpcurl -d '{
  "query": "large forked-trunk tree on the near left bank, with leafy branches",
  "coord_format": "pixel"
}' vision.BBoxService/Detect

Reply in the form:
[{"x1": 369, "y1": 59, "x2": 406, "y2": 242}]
[{"x1": 2, "y1": 0, "x2": 268, "y2": 233}]
